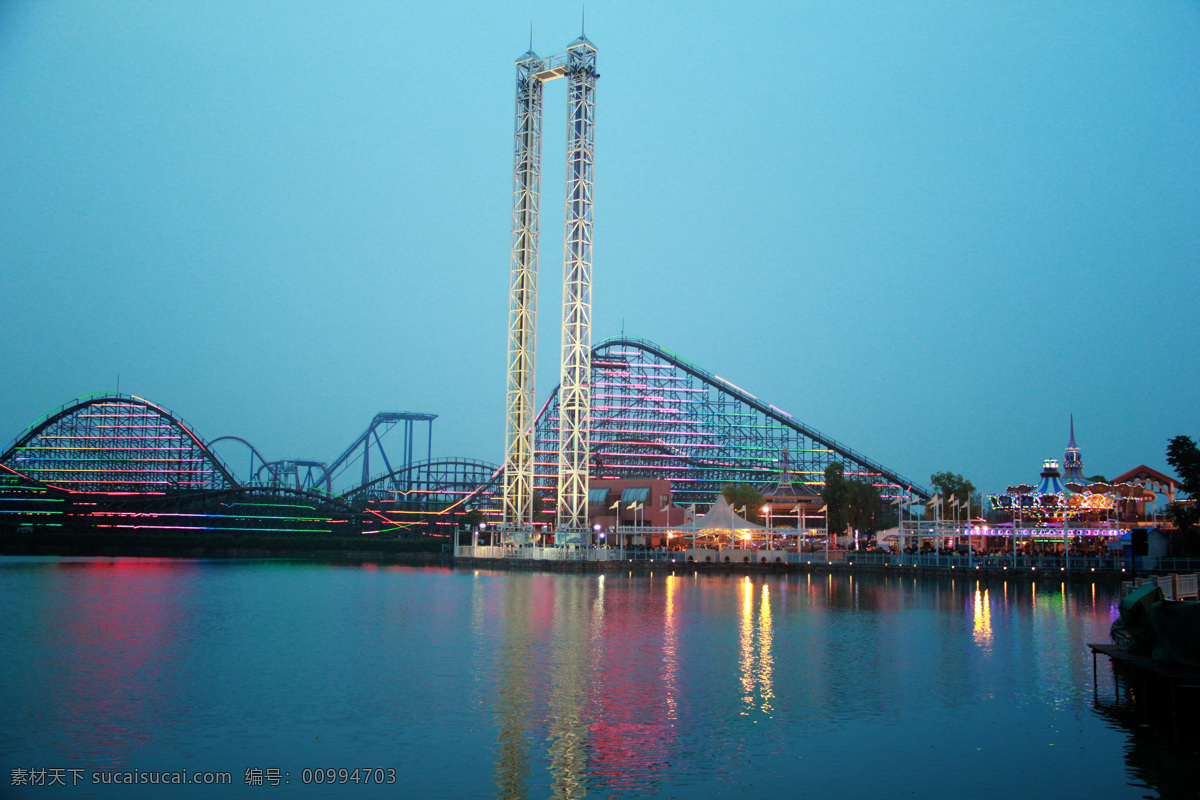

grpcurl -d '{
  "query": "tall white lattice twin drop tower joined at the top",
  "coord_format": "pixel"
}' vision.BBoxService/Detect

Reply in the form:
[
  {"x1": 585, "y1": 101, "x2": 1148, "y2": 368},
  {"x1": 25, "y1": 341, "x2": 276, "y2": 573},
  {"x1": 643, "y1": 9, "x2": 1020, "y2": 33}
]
[{"x1": 504, "y1": 34, "x2": 600, "y2": 543}]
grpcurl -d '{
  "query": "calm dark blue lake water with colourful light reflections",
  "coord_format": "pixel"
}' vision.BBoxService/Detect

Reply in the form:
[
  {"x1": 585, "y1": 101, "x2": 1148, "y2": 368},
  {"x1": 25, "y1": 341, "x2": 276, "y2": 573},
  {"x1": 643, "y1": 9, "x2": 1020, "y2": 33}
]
[{"x1": 0, "y1": 558, "x2": 1200, "y2": 800}]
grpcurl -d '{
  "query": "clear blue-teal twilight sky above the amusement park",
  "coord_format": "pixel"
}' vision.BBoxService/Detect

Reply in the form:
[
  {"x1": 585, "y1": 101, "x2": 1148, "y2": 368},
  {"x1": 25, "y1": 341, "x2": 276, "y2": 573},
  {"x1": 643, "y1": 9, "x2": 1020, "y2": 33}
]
[{"x1": 0, "y1": 0, "x2": 1200, "y2": 501}]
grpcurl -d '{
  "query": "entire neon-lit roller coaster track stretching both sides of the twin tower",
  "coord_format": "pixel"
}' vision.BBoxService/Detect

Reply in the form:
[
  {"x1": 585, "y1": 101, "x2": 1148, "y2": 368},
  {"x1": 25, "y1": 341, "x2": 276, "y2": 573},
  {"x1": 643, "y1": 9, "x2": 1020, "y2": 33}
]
[{"x1": 0, "y1": 337, "x2": 929, "y2": 537}]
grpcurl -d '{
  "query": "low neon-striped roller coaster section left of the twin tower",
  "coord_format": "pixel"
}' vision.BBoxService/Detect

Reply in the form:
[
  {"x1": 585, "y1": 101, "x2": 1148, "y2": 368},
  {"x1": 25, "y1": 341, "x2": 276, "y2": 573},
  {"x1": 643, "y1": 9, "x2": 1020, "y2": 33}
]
[{"x1": 0, "y1": 395, "x2": 498, "y2": 539}]
